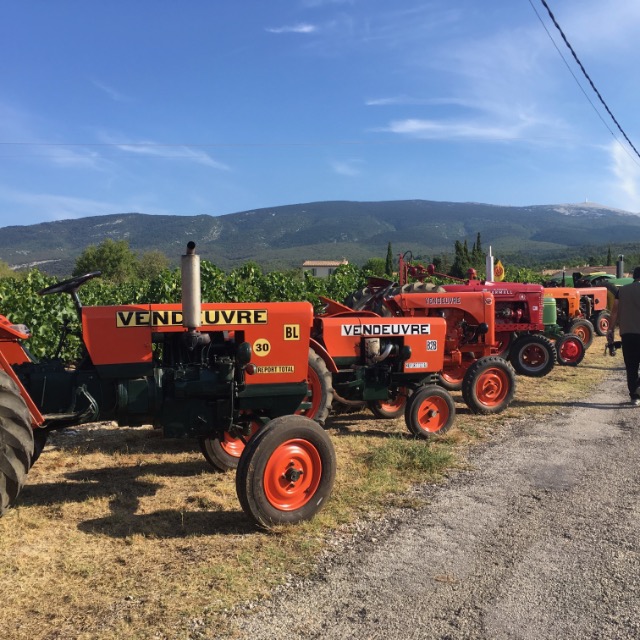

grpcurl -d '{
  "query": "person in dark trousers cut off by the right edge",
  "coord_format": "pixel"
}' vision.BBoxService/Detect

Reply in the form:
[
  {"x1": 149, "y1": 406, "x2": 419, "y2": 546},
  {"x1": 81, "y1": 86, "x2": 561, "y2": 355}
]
[{"x1": 607, "y1": 267, "x2": 640, "y2": 406}]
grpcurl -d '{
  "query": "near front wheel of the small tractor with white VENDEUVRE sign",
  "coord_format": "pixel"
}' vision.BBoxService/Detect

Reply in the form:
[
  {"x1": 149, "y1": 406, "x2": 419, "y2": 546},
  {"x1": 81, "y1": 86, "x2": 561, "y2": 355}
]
[{"x1": 404, "y1": 384, "x2": 456, "y2": 439}]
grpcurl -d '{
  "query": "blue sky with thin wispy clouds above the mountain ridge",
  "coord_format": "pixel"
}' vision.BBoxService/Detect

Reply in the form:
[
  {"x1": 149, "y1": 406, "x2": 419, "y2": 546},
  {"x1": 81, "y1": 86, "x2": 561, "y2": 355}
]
[{"x1": 0, "y1": 0, "x2": 640, "y2": 226}]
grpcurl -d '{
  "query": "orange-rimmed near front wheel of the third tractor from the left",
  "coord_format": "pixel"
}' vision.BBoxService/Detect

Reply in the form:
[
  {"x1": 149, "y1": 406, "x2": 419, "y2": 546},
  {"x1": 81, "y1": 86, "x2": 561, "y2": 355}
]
[{"x1": 462, "y1": 356, "x2": 516, "y2": 415}]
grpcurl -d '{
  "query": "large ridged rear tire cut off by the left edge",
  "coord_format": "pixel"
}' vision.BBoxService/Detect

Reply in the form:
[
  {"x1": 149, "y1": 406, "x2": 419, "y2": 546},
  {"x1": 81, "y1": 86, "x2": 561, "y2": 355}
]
[{"x1": 0, "y1": 371, "x2": 33, "y2": 516}]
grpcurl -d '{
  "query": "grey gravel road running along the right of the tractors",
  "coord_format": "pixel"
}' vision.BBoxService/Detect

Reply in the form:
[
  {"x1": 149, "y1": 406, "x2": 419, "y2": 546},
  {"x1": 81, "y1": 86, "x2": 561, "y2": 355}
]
[{"x1": 224, "y1": 370, "x2": 640, "y2": 640}]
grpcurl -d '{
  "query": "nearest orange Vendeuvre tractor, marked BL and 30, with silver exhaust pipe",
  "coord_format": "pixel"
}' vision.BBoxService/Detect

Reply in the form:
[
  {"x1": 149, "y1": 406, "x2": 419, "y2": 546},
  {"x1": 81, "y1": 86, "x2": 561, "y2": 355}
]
[{"x1": 0, "y1": 243, "x2": 336, "y2": 527}]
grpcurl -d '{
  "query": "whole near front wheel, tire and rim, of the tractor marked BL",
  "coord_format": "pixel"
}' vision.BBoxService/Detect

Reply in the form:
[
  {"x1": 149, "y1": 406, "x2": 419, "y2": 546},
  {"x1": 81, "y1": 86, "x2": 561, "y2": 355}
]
[{"x1": 236, "y1": 415, "x2": 336, "y2": 529}]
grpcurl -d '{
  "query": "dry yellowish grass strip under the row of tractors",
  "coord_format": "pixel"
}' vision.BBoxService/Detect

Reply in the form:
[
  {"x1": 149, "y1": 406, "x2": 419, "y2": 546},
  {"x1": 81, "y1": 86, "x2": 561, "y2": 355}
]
[{"x1": 0, "y1": 338, "x2": 623, "y2": 640}]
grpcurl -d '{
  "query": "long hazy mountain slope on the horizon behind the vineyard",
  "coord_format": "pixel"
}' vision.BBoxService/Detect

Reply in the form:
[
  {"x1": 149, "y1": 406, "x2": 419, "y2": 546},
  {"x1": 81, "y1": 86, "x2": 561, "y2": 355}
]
[{"x1": 0, "y1": 200, "x2": 640, "y2": 275}]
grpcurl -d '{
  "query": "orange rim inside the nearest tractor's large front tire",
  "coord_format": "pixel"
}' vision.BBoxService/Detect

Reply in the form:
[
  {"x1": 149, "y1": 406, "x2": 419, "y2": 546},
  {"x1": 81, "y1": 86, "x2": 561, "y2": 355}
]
[{"x1": 263, "y1": 439, "x2": 322, "y2": 511}]
